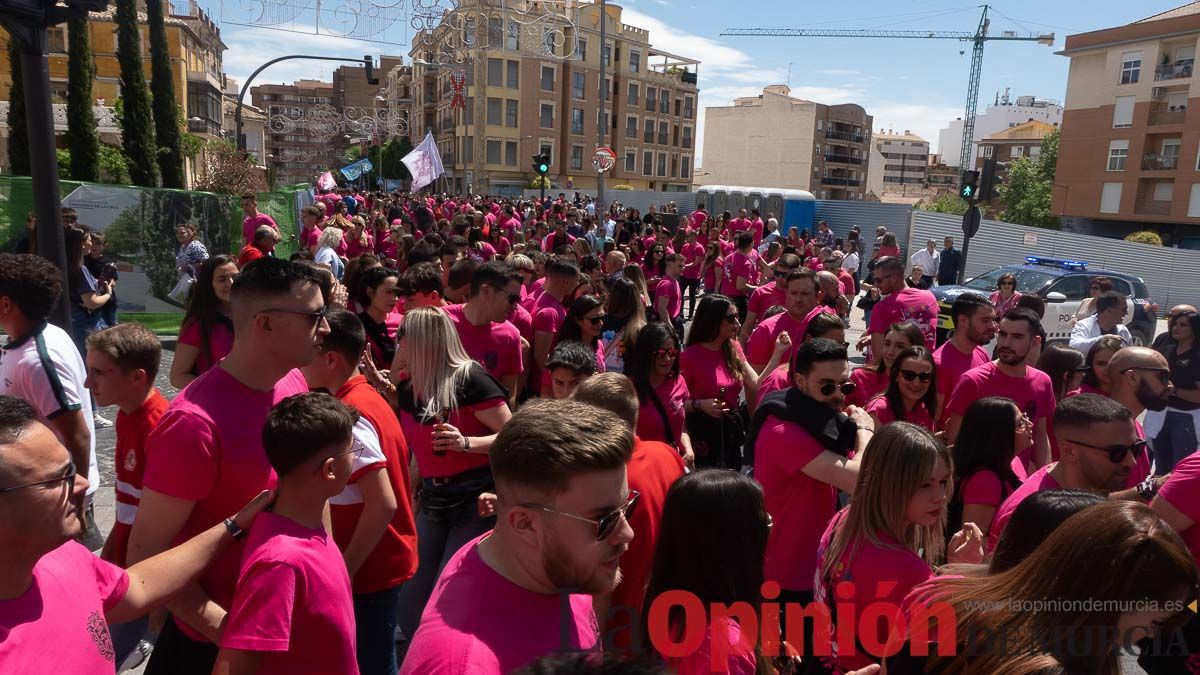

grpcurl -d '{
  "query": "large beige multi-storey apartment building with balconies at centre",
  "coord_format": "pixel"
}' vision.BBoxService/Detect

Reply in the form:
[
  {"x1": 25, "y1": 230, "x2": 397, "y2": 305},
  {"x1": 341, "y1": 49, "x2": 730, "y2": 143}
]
[{"x1": 409, "y1": 0, "x2": 700, "y2": 195}]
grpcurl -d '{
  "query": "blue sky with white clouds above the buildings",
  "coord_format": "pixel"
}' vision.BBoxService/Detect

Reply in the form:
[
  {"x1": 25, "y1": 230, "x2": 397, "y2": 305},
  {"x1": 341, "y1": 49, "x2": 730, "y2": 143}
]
[{"x1": 200, "y1": 0, "x2": 1183, "y2": 166}]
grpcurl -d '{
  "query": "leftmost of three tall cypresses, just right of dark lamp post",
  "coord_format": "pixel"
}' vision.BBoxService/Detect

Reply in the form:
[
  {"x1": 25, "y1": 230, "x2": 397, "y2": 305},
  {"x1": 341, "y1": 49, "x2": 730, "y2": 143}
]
[{"x1": 59, "y1": 14, "x2": 100, "y2": 183}]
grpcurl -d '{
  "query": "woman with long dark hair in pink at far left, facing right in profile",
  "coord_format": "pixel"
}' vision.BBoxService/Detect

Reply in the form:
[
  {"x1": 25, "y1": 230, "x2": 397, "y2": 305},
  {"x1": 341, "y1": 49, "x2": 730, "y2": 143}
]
[{"x1": 170, "y1": 255, "x2": 238, "y2": 389}]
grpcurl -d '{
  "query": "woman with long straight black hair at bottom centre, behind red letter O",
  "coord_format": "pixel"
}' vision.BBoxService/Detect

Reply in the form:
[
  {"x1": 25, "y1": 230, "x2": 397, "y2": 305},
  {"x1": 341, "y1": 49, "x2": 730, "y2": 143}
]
[{"x1": 641, "y1": 471, "x2": 772, "y2": 675}]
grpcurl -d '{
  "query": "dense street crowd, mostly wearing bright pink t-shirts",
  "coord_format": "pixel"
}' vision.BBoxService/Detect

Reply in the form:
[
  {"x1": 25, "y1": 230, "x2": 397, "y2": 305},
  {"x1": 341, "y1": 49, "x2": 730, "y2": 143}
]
[{"x1": 7, "y1": 189, "x2": 1200, "y2": 675}]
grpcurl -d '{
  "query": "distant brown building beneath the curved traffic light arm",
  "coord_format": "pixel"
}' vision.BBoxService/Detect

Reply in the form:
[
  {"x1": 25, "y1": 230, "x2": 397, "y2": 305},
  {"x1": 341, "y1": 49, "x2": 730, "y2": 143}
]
[{"x1": 250, "y1": 79, "x2": 344, "y2": 185}]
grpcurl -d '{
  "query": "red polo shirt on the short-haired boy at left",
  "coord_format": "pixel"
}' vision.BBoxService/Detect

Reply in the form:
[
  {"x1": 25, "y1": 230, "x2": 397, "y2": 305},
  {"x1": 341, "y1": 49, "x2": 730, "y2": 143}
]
[{"x1": 109, "y1": 389, "x2": 170, "y2": 567}]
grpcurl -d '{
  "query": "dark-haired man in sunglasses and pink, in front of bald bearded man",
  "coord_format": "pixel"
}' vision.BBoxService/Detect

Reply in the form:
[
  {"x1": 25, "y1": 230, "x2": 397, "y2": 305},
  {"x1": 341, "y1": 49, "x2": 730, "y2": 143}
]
[{"x1": 988, "y1": 393, "x2": 1146, "y2": 550}]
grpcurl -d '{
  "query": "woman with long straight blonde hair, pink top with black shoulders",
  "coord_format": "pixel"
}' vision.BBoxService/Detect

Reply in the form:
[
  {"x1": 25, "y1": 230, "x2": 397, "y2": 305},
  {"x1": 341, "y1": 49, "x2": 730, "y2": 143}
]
[{"x1": 392, "y1": 307, "x2": 512, "y2": 638}]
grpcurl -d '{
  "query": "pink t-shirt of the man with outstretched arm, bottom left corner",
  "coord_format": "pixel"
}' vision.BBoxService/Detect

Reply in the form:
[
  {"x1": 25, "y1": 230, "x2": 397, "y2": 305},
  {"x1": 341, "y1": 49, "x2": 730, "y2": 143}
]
[{"x1": 0, "y1": 542, "x2": 130, "y2": 673}]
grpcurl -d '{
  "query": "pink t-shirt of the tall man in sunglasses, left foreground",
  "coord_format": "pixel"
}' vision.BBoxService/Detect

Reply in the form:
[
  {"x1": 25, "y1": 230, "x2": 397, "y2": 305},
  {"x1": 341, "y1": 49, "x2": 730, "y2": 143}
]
[{"x1": 145, "y1": 368, "x2": 308, "y2": 641}]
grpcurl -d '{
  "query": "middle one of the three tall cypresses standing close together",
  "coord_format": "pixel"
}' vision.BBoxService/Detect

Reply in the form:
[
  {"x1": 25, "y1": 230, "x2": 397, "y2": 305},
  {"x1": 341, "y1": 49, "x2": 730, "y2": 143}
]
[{"x1": 115, "y1": 0, "x2": 158, "y2": 187}]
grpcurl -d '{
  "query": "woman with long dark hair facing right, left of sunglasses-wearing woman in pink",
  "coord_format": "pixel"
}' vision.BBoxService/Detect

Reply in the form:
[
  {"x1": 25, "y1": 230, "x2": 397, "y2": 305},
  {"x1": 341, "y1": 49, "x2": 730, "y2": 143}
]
[{"x1": 625, "y1": 323, "x2": 696, "y2": 466}]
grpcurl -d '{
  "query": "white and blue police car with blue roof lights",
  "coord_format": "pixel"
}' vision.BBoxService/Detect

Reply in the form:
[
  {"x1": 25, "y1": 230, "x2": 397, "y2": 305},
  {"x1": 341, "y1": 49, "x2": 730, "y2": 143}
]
[{"x1": 931, "y1": 256, "x2": 1158, "y2": 345}]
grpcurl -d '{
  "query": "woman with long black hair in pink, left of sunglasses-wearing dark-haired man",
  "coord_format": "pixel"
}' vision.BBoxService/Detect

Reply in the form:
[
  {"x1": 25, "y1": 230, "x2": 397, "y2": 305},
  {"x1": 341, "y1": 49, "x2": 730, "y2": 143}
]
[{"x1": 948, "y1": 396, "x2": 1033, "y2": 539}]
